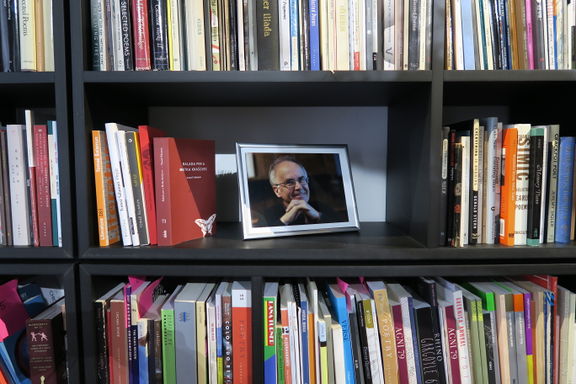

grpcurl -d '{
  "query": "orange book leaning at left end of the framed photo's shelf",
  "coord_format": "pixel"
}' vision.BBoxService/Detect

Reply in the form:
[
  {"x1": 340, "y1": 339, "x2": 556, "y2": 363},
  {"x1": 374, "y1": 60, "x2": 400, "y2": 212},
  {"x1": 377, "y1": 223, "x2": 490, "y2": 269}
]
[{"x1": 92, "y1": 130, "x2": 120, "y2": 247}]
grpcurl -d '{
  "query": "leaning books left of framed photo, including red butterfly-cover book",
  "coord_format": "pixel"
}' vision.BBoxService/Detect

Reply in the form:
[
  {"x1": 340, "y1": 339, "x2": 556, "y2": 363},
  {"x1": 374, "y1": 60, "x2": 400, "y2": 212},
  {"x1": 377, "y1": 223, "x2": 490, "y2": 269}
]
[{"x1": 92, "y1": 123, "x2": 216, "y2": 246}]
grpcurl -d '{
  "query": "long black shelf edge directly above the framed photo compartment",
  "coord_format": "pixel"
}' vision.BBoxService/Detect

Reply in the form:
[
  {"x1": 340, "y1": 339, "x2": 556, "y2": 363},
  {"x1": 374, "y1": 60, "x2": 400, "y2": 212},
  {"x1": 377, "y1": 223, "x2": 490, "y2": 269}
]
[{"x1": 83, "y1": 71, "x2": 432, "y2": 83}]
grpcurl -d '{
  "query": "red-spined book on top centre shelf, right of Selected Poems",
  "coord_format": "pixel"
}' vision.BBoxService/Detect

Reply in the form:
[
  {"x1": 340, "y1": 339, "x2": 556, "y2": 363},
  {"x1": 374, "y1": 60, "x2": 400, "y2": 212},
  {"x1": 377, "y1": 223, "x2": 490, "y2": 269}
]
[{"x1": 130, "y1": 0, "x2": 152, "y2": 71}]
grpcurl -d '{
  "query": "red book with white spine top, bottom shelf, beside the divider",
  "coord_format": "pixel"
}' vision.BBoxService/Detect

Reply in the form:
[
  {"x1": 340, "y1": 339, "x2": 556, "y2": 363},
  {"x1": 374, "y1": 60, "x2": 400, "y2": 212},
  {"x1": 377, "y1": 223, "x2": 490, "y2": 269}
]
[{"x1": 232, "y1": 281, "x2": 252, "y2": 384}]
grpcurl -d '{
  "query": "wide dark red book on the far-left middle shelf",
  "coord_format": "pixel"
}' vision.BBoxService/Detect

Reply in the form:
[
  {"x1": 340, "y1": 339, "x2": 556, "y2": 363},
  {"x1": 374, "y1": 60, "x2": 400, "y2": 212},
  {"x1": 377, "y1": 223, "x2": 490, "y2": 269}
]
[{"x1": 34, "y1": 125, "x2": 53, "y2": 247}]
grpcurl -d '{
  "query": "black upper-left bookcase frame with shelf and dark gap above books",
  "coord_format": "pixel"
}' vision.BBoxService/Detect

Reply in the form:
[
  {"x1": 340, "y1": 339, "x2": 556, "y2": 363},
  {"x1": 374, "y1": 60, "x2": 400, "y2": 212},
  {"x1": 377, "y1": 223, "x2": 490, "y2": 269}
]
[{"x1": 0, "y1": 0, "x2": 76, "y2": 260}]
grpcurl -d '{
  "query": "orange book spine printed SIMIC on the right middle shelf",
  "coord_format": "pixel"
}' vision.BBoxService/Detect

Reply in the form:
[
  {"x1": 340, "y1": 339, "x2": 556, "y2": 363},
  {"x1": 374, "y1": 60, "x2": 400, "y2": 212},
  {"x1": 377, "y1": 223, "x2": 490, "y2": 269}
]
[{"x1": 500, "y1": 127, "x2": 518, "y2": 246}]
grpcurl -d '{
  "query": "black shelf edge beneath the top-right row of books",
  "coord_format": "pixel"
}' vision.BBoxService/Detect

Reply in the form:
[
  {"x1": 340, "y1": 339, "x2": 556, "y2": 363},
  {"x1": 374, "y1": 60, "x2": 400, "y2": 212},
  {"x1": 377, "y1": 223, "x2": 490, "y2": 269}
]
[{"x1": 444, "y1": 70, "x2": 576, "y2": 83}]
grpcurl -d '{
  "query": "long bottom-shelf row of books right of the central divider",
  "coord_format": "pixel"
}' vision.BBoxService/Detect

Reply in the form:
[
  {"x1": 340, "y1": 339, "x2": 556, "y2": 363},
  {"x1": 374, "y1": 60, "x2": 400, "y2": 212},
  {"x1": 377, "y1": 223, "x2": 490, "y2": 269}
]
[{"x1": 263, "y1": 276, "x2": 576, "y2": 384}]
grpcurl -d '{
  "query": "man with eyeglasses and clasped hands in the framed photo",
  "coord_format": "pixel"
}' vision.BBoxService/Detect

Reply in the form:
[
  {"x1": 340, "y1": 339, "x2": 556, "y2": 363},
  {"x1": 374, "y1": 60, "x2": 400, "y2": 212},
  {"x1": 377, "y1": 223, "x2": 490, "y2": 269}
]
[{"x1": 266, "y1": 157, "x2": 322, "y2": 225}]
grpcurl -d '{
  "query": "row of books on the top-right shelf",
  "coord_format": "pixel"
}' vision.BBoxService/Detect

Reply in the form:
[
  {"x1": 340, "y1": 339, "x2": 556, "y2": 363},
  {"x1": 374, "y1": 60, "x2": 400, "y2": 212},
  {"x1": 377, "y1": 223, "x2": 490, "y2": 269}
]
[{"x1": 445, "y1": 0, "x2": 576, "y2": 70}]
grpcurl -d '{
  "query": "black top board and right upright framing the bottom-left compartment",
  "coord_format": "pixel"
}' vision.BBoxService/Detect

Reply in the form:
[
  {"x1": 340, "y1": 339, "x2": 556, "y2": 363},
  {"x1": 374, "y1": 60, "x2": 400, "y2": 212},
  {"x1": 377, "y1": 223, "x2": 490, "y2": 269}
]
[{"x1": 0, "y1": 263, "x2": 82, "y2": 383}]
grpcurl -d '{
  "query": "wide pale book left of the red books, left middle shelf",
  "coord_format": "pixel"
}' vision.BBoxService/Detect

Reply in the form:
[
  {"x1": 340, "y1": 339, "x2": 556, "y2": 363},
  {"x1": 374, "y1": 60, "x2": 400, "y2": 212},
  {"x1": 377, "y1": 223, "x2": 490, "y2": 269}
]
[{"x1": 6, "y1": 124, "x2": 32, "y2": 246}]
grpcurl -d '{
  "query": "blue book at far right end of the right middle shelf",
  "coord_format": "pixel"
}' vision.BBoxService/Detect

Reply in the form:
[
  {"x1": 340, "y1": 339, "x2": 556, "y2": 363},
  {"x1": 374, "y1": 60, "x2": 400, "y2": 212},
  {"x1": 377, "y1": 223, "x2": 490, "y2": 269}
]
[{"x1": 554, "y1": 137, "x2": 575, "y2": 243}]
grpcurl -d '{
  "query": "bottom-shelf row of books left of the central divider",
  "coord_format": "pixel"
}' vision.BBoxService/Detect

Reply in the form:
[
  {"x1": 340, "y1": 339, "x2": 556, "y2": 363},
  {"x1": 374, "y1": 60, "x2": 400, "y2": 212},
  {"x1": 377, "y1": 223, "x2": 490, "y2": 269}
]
[{"x1": 95, "y1": 277, "x2": 252, "y2": 384}]
